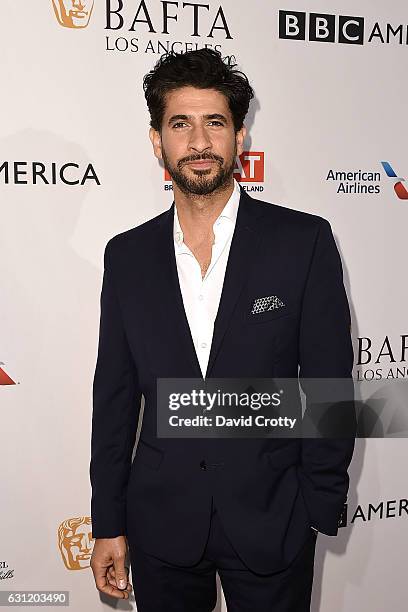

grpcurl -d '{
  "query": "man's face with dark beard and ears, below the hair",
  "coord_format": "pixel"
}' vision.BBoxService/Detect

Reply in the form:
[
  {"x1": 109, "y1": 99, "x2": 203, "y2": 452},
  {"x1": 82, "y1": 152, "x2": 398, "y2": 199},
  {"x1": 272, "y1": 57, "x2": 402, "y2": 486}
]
[{"x1": 149, "y1": 86, "x2": 246, "y2": 195}]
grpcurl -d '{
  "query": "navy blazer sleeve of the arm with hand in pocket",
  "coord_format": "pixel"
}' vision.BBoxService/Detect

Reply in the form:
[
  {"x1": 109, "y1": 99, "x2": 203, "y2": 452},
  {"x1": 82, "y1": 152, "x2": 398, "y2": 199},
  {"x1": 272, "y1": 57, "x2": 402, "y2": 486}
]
[{"x1": 299, "y1": 218, "x2": 356, "y2": 535}]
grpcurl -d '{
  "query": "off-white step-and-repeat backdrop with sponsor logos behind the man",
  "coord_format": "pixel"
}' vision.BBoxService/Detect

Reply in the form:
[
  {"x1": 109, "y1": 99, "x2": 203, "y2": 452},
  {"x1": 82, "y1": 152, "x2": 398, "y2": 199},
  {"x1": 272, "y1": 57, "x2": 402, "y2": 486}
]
[{"x1": 0, "y1": 0, "x2": 408, "y2": 612}]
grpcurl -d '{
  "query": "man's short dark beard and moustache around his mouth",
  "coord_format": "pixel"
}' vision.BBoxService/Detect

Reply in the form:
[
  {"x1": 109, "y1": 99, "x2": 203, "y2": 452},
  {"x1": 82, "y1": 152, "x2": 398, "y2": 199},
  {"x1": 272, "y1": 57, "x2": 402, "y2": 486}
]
[{"x1": 162, "y1": 143, "x2": 237, "y2": 196}]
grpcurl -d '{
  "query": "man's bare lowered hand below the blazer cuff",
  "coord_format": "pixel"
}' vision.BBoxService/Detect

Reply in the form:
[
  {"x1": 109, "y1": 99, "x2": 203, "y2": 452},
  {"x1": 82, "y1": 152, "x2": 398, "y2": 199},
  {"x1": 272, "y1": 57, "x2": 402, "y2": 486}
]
[{"x1": 91, "y1": 536, "x2": 132, "y2": 599}]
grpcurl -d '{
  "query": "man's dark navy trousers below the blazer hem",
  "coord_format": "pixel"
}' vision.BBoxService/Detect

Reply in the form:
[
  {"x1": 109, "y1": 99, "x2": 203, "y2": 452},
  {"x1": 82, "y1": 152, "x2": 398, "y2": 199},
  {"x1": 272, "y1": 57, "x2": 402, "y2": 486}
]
[{"x1": 129, "y1": 504, "x2": 317, "y2": 612}]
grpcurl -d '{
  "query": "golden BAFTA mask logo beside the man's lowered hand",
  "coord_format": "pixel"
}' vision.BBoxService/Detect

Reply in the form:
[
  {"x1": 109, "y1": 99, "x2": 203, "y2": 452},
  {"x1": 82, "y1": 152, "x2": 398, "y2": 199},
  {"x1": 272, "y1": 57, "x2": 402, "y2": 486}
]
[{"x1": 58, "y1": 516, "x2": 94, "y2": 570}]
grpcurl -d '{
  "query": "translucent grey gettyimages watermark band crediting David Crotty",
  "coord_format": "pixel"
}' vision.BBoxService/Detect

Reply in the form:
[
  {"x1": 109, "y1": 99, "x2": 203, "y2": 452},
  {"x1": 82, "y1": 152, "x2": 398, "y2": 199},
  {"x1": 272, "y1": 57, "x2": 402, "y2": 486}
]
[{"x1": 157, "y1": 378, "x2": 408, "y2": 438}]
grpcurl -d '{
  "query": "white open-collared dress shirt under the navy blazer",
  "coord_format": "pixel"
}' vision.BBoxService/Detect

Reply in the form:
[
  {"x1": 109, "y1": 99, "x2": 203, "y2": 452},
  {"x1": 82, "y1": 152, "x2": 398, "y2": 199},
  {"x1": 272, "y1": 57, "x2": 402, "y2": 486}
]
[{"x1": 173, "y1": 179, "x2": 241, "y2": 378}]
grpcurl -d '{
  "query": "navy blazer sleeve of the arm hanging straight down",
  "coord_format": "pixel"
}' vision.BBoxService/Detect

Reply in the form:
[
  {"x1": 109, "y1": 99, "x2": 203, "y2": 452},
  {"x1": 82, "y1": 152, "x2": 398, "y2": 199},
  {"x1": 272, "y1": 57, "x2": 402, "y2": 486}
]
[{"x1": 90, "y1": 239, "x2": 141, "y2": 538}]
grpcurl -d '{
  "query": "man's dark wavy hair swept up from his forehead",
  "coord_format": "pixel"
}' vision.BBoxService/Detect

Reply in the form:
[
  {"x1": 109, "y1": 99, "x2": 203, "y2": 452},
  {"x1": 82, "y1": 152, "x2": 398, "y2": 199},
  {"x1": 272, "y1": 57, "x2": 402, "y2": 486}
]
[{"x1": 143, "y1": 49, "x2": 254, "y2": 132}]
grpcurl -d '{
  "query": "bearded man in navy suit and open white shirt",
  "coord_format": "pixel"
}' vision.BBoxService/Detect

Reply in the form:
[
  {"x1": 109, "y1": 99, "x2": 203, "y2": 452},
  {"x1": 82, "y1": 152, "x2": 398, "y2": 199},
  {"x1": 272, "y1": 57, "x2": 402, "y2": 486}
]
[{"x1": 91, "y1": 49, "x2": 354, "y2": 612}]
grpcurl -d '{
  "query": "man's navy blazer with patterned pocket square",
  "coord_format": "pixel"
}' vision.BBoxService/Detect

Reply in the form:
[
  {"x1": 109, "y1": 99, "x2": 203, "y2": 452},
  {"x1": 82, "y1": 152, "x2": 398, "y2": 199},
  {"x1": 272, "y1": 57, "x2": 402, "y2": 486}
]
[{"x1": 90, "y1": 188, "x2": 354, "y2": 573}]
